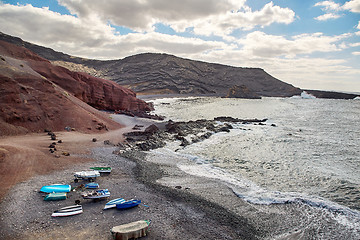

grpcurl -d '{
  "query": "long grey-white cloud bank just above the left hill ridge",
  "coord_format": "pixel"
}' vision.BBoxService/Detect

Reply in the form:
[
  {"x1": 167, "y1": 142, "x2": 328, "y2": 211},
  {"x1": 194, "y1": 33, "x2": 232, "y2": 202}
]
[{"x1": 0, "y1": 4, "x2": 231, "y2": 59}]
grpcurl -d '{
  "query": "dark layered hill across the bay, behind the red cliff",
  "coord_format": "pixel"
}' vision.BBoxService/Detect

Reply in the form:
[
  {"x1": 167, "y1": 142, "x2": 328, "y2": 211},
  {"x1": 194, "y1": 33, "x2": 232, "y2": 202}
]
[{"x1": 0, "y1": 32, "x2": 357, "y2": 99}]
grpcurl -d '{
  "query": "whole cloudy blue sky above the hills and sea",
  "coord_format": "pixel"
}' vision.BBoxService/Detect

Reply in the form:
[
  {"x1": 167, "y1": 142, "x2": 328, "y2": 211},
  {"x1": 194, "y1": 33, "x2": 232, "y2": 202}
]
[{"x1": 0, "y1": 0, "x2": 360, "y2": 92}]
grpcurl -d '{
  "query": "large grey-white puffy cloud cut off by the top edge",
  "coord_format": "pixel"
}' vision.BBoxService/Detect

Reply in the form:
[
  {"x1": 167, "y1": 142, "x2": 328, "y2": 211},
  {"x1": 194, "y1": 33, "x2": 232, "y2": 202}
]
[{"x1": 59, "y1": 0, "x2": 295, "y2": 36}]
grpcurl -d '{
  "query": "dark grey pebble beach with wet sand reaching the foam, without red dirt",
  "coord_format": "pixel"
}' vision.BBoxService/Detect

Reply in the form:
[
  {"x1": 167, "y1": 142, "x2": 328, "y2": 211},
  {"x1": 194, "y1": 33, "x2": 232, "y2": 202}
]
[{"x1": 0, "y1": 104, "x2": 357, "y2": 239}]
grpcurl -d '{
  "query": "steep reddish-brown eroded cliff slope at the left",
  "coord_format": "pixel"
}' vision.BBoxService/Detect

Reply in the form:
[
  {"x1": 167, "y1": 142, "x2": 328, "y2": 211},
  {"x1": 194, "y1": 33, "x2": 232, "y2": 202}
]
[{"x1": 0, "y1": 41, "x2": 151, "y2": 135}]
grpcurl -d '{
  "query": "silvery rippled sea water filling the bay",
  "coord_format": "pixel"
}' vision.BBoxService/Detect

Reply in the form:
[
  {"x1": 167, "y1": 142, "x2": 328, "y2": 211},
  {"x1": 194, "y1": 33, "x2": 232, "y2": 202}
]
[{"x1": 148, "y1": 97, "x2": 360, "y2": 239}]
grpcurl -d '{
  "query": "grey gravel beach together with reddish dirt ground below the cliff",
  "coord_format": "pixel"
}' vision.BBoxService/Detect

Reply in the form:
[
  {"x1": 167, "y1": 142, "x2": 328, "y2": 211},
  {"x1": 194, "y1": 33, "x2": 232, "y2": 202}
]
[{"x1": 0, "y1": 113, "x2": 260, "y2": 239}]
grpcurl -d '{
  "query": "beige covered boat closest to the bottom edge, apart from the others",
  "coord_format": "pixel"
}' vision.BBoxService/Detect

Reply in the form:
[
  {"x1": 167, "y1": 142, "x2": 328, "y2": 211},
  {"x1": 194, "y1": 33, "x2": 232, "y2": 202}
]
[{"x1": 111, "y1": 220, "x2": 151, "y2": 240}]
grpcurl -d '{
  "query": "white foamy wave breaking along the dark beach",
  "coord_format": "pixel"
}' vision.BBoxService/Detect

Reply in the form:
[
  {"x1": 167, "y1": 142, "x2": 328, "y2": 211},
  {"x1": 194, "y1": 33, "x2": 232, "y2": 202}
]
[{"x1": 152, "y1": 148, "x2": 360, "y2": 229}]
